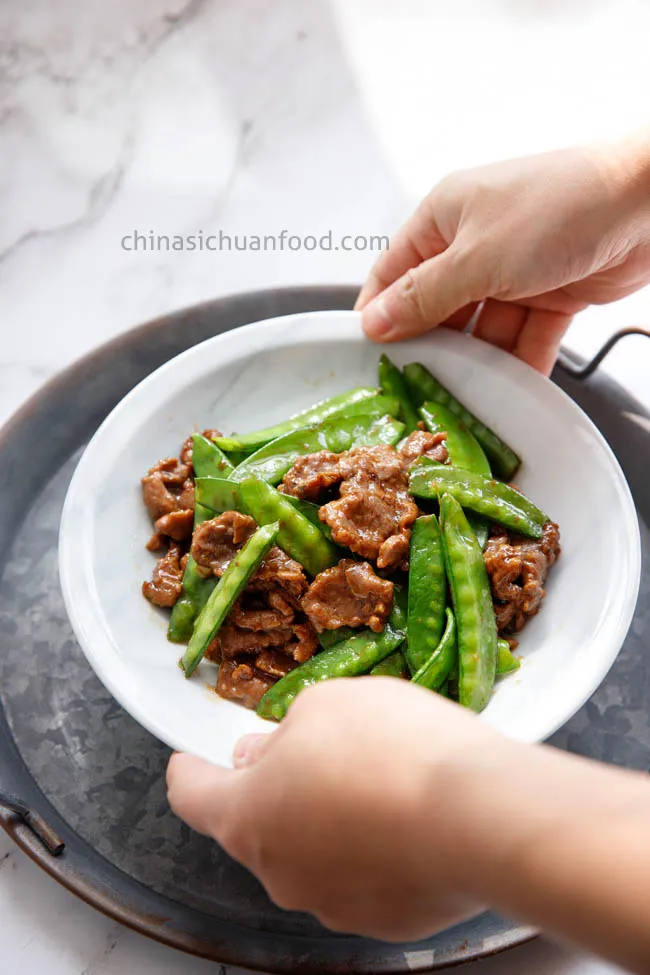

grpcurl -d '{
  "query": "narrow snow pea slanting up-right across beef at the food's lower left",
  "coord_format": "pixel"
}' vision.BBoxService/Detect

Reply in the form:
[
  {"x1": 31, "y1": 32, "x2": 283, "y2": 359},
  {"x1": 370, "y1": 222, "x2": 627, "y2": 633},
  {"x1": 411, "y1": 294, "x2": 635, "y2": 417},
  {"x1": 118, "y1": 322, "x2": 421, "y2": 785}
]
[{"x1": 181, "y1": 522, "x2": 280, "y2": 677}]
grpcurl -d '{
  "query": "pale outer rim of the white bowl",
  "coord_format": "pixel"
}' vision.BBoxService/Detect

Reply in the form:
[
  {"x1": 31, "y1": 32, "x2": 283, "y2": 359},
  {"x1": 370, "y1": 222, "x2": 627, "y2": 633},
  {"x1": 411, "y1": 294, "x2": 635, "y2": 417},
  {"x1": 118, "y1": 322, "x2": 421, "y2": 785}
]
[{"x1": 59, "y1": 310, "x2": 641, "y2": 751}]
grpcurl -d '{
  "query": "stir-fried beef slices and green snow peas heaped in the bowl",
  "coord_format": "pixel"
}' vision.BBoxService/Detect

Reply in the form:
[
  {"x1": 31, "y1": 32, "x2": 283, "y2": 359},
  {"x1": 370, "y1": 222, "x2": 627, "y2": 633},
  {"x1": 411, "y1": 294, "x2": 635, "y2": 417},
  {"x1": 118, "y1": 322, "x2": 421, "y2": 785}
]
[{"x1": 142, "y1": 356, "x2": 560, "y2": 720}]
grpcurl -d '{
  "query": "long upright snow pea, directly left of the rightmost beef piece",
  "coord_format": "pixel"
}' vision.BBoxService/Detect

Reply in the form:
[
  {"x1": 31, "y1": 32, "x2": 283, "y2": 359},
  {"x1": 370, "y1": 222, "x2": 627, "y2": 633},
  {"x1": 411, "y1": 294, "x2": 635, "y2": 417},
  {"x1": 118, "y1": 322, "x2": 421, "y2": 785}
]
[{"x1": 440, "y1": 494, "x2": 497, "y2": 711}]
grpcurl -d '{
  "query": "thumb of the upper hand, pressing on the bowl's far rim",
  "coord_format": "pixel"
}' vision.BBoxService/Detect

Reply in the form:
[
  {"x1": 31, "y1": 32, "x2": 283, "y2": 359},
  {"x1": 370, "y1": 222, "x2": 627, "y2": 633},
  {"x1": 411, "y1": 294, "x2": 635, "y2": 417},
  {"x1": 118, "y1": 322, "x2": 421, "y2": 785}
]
[{"x1": 362, "y1": 244, "x2": 486, "y2": 342}]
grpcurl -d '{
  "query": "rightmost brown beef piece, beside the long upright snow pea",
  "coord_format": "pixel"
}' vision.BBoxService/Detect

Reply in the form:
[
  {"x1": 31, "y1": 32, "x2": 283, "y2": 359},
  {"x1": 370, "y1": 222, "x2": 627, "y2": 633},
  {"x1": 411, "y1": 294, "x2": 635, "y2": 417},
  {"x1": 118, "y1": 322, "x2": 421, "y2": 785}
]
[{"x1": 483, "y1": 521, "x2": 561, "y2": 635}]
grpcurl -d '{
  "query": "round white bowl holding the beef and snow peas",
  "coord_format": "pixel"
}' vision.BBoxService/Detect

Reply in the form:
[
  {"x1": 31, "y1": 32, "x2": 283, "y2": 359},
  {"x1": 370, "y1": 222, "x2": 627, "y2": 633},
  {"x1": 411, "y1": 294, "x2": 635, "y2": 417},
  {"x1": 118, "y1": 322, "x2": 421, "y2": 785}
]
[{"x1": 60, "y1": 312, "x2": 641, "y2": 765}]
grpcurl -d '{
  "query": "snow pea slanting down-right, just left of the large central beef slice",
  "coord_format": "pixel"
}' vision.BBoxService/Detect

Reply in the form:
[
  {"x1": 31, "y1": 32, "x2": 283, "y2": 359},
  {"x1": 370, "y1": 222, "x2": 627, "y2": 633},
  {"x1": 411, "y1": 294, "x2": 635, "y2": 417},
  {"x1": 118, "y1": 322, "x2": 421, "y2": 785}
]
[{"x1": 239, "y1": 477, "x2": 341, "y2": 576}]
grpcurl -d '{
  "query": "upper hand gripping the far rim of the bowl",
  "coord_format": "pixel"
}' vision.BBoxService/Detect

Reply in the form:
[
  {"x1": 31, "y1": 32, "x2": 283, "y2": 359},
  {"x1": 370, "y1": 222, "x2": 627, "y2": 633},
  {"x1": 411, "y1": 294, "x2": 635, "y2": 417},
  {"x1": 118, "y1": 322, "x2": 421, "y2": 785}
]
[{"x1": 356, "y1": 139, "x2": 650, "y2": 374}]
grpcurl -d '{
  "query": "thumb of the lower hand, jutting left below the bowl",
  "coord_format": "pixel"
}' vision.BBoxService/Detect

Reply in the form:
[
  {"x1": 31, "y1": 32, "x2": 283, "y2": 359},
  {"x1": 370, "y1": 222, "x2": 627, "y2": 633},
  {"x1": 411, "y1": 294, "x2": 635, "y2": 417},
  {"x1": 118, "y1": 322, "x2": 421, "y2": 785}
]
[{"x1": 167, "y1": 752, "x2": 237, "y2": 836}]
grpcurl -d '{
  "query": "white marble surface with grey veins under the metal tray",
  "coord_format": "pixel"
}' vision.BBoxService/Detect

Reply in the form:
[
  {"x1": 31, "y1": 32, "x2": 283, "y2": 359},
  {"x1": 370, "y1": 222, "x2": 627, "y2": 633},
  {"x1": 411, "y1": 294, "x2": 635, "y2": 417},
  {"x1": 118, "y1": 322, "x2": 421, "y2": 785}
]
[{"x1": 0, "y1": 0, "x2": 650, "y2": 975}]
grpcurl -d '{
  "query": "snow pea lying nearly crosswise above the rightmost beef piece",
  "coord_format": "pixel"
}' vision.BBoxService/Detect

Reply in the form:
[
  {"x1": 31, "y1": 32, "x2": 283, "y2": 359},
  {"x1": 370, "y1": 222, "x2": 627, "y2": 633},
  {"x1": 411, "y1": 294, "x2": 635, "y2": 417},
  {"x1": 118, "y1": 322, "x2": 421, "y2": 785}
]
[{"x1": 409, "y1": 464, "x2": 548, "y2": 538}]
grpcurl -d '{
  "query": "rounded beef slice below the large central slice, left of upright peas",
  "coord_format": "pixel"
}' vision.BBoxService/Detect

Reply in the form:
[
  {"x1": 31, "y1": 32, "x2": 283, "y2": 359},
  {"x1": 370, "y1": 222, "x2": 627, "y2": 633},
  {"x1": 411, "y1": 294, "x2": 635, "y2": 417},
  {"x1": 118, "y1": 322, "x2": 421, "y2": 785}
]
[{"x1": 302, "y1": 559, "x2": 394, "y2": 633}]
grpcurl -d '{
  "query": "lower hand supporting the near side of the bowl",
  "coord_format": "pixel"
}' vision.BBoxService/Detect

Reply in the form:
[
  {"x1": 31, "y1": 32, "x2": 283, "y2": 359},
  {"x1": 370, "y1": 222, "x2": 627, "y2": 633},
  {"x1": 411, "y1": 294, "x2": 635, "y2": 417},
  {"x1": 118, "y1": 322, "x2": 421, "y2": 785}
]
[{"x1": 168, "y1": 677, "x2": 502, "y2": 941}]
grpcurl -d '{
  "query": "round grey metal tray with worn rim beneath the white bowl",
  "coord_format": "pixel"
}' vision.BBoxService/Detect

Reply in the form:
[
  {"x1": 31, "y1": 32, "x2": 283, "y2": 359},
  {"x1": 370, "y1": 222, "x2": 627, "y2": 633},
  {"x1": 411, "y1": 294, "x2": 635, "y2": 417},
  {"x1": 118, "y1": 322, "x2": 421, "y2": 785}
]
[{"x1": 0, "y1": 288, "x2": 650, "y2": 975}]
